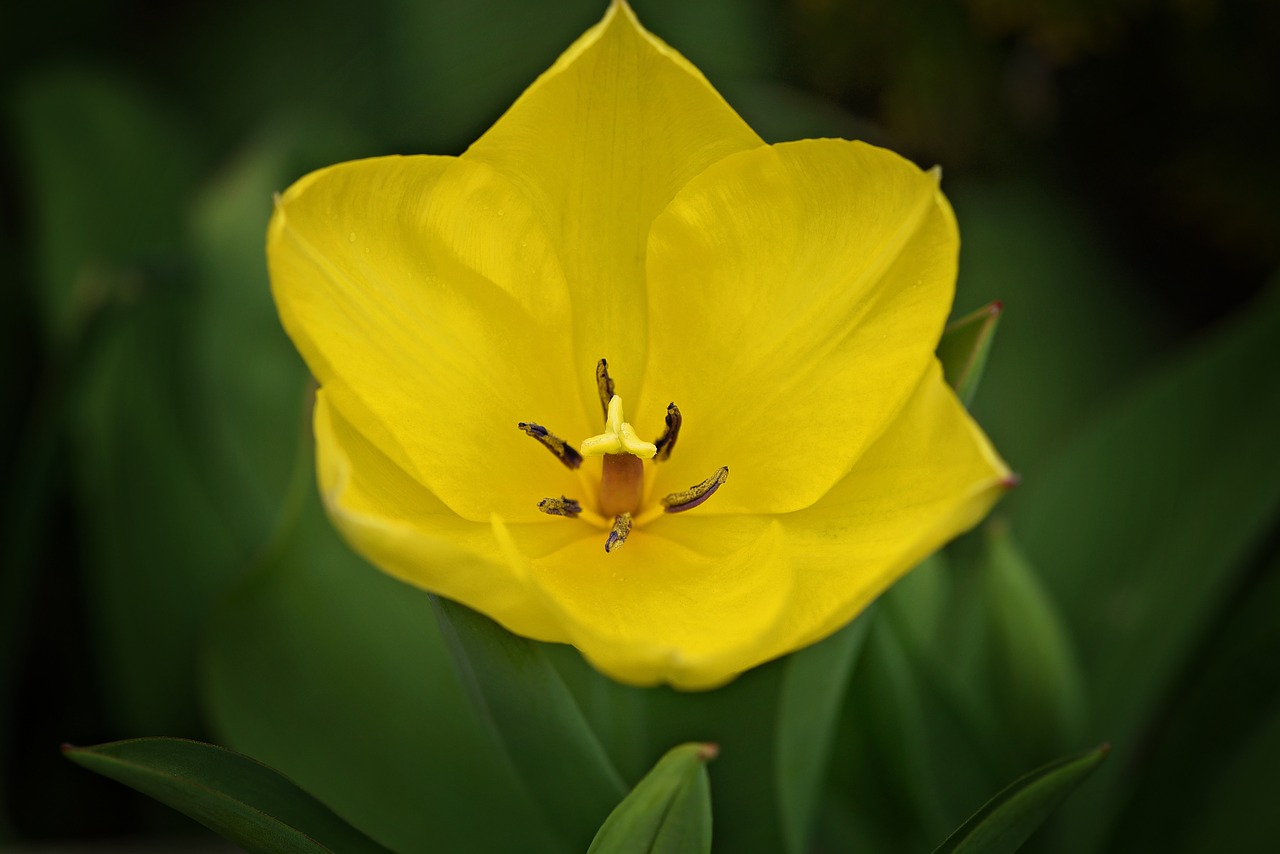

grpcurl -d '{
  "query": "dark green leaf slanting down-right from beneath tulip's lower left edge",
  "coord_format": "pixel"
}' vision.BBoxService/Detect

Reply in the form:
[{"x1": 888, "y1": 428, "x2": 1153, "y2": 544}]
[{"x1": 431, "y1": 597, "x2": 626, "y2": 850}]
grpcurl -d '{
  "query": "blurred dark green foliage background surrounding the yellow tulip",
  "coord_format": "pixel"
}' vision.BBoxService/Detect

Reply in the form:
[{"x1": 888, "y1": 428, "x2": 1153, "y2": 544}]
[{"x1": 0, "y1": 0, "x2": 1280, "y2": 851}]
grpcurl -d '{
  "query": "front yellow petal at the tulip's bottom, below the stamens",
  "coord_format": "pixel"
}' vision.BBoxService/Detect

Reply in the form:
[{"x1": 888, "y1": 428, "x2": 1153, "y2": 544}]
[{"x1": 509, "y1": 517, "x2": 791, "y2": 690}]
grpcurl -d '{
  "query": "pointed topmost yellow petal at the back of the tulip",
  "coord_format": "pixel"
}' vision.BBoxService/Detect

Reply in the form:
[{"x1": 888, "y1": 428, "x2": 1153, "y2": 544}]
[{"x1": 463, "y1": 3, "x2": 763, "y2": 409}]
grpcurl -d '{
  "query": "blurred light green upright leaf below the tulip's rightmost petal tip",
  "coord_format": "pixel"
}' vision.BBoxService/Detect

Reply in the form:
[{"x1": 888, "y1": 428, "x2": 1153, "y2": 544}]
[{"x1": 980, "y1": 520, "x2": 1084, "y2": 767}]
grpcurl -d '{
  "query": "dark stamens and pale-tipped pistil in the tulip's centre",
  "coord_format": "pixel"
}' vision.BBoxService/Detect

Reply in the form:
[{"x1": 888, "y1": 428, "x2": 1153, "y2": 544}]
[{"x1": 518, "y1": 359, "x2": 728, "y2": 552}]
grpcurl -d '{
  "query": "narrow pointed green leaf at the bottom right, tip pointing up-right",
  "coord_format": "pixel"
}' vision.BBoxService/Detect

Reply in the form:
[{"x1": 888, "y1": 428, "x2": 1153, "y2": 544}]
[{"x1": 934, "y1": 745, "x2": 1110, "y2": 854}]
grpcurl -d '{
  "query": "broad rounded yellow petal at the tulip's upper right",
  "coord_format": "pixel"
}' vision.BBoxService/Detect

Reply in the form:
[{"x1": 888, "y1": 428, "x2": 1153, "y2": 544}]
[{"x1": 640, "y1": 140, "x2": 959, "y2": 513}]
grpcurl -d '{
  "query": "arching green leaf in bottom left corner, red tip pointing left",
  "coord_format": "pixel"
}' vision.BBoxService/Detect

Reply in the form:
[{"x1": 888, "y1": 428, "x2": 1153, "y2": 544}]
[{"x1": 63, "y1": 739, "x2": 387, "y2": 854}]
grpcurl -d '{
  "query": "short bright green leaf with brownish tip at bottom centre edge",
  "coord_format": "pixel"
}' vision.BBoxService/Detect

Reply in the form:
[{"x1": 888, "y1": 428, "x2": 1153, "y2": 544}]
[{"x1": 588, "y1": 744, "x2": 718, "y2": 854}]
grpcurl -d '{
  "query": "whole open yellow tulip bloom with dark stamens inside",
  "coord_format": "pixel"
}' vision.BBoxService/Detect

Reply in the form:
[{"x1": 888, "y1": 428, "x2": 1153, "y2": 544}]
[{"x1": 268, "y1": 0, "x2": 1010, "y2": 689}]
